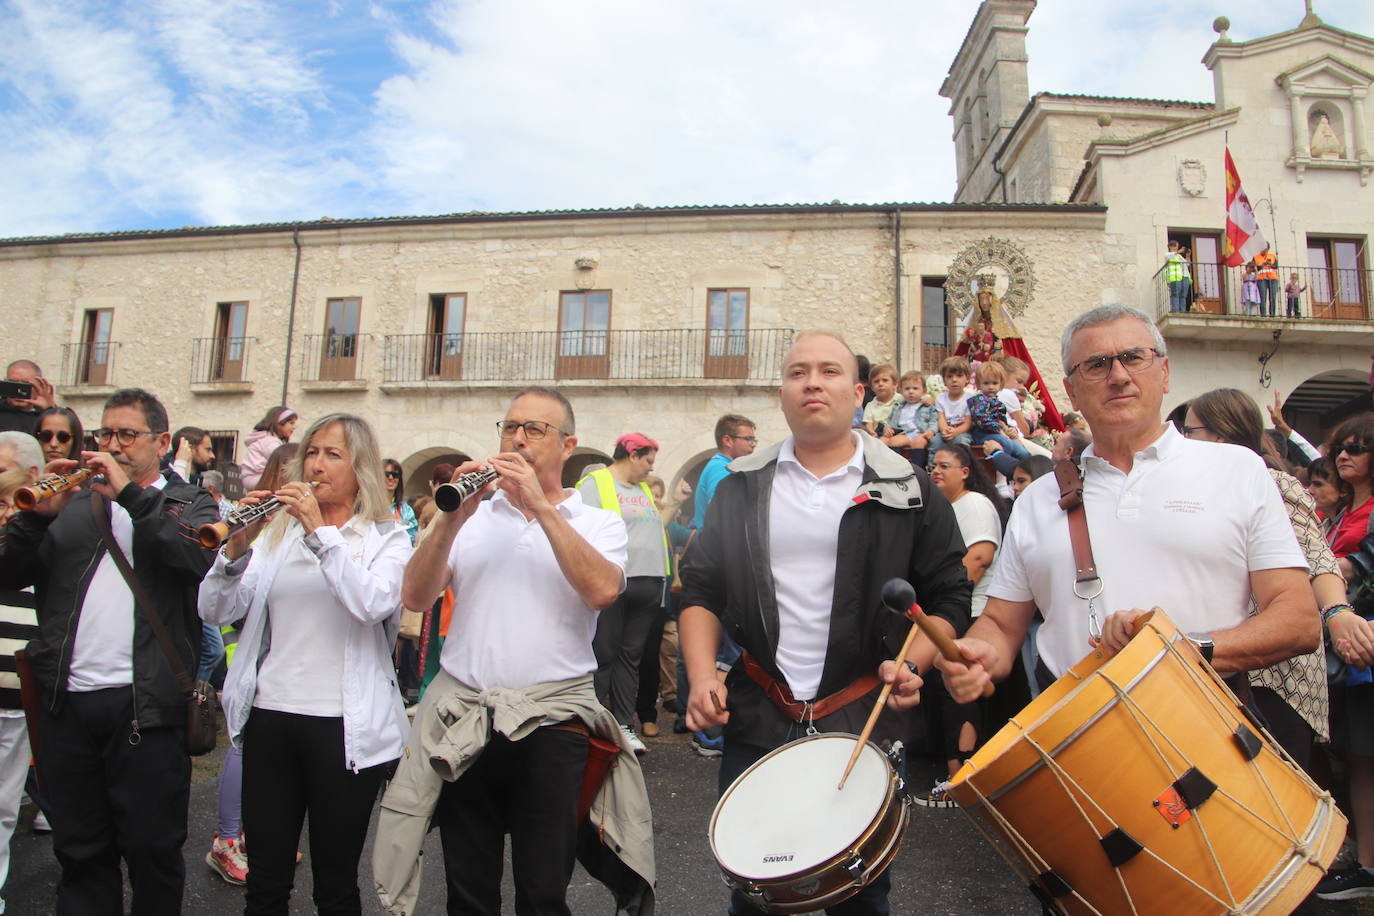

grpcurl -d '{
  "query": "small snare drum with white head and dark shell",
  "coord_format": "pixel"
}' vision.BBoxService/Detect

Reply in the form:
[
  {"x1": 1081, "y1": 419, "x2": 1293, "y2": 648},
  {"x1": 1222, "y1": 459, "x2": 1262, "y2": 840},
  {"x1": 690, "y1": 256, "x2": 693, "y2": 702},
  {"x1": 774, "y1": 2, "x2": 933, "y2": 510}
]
[{"x1": 710, "y1": 733, "x2": 908, "y2": 913}]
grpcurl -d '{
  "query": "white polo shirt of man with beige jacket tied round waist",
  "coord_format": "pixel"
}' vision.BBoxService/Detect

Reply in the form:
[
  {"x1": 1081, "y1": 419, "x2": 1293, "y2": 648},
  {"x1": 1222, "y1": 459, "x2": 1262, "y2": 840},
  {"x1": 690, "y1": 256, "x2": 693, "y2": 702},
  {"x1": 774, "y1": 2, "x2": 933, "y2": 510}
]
[{"x1": 440, "y1": 489, "x2": 627, "y2": 691}]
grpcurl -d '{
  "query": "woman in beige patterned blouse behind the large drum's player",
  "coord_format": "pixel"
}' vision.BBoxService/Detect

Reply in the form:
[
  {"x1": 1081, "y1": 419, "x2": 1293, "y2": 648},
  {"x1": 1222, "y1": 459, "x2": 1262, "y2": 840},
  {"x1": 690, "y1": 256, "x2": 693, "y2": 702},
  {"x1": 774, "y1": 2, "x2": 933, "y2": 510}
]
[{"x1": 1183, "y1": 389, "x2": 1355, "y2": 768}]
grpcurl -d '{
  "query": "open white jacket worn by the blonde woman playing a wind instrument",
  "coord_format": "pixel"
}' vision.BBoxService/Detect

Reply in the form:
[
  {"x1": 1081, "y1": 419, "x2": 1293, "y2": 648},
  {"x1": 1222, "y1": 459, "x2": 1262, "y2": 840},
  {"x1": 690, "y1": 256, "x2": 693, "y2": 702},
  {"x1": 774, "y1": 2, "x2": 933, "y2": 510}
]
[{"x1": 199, "y1": 519, "x2": 411, "y2": 772}]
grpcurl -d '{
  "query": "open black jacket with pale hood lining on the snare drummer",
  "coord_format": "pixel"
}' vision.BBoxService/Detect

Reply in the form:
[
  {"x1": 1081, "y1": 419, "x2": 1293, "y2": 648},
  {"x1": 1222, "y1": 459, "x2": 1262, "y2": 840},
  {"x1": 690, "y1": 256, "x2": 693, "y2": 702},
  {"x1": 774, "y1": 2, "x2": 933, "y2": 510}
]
[{"x1": 680, "y1": 434, "x2": 973, "y2": 748}]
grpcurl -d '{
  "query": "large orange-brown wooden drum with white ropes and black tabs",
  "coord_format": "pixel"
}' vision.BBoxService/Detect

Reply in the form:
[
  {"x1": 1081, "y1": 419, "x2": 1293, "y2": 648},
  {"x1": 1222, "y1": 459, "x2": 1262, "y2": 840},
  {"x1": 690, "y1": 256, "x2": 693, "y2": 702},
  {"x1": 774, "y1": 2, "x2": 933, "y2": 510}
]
[{"x1": 949, "y1": 610, "x2": 1345, "y2": 916}]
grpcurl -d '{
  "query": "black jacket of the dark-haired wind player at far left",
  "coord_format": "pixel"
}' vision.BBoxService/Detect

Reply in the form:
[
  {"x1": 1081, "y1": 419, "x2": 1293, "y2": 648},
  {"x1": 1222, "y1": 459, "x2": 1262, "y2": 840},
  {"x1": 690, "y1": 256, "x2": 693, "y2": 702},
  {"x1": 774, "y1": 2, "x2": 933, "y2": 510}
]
[{"x1": 0, "y1": 475, "x2": 220, "y2": 729}]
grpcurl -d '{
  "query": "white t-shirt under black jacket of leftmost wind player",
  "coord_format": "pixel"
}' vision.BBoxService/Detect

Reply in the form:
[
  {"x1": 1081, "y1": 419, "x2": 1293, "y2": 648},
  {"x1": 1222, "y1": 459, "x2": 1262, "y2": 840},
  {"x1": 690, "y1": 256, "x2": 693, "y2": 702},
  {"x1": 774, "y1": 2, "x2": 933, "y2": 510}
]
[{"x1": 67, "y1": 474, "x2": 168, "y2": 694}]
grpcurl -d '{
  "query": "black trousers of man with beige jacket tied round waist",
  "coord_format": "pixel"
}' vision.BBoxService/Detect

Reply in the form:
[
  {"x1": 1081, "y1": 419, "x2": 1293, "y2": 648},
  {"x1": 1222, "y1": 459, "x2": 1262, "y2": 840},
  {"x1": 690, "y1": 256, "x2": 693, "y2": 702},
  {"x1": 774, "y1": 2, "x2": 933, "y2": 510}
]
[{"x1": 434, "y1": 725, "x2": 587, "y2": 916}]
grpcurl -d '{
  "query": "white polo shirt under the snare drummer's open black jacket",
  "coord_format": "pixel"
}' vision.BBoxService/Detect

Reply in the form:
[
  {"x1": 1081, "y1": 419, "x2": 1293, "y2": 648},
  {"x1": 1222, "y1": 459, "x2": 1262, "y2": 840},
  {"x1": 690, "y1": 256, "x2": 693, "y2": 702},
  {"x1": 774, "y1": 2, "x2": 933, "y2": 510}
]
[{"x1": 768, "y1": 435, "x2": 863, "y2": 700}]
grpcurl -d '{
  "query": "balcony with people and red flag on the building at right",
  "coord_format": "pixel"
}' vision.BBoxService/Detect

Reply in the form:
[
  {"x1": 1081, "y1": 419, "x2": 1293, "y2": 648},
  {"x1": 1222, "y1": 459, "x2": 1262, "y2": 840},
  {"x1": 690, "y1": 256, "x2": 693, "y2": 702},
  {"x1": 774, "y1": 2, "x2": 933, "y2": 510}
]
[{"x1": 1153, "y1": 264, "x2": 1374, "y2": 343}]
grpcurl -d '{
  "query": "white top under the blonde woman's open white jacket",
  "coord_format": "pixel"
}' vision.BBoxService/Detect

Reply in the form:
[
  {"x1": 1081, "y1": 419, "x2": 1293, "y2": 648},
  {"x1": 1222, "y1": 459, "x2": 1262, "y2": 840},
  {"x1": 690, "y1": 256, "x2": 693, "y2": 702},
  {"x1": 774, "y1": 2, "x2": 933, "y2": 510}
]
[{"x1": 253, "y1": 518, "x2": 367, "y2": 715}]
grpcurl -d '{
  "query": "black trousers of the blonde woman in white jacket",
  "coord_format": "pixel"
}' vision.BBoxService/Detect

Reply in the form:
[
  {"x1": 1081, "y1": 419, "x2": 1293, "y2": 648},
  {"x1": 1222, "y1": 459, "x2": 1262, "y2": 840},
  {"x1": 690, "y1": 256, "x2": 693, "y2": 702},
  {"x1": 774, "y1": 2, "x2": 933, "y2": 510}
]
[{"x1": 243, "y1": 709, "x2": 387, "y2": 916}]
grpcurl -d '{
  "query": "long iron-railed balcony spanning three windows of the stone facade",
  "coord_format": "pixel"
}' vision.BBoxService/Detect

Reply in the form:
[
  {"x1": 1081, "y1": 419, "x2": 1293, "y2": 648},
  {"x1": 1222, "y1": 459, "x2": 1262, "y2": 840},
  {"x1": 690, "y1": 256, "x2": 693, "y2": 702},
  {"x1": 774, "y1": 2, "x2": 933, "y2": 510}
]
[{"x1": 382, "y1": 328, "x2": 794, "y2": 387}]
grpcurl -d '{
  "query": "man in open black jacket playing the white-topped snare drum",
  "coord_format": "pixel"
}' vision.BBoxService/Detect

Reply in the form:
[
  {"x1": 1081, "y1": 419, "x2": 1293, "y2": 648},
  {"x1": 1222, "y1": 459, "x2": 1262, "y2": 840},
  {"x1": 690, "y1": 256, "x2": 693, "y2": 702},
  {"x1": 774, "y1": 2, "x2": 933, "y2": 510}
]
[{"x1": 679, "y1": 332, "x2": 971, "y2": 916}]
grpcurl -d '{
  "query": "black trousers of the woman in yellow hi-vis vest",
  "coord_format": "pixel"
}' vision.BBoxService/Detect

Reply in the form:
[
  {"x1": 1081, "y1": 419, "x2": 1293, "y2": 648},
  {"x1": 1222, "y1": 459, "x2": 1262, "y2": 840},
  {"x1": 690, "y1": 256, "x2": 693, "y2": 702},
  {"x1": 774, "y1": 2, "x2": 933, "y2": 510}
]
[{"x1": 592, "y1": 575, "x2": 664, "y2": 725}]
